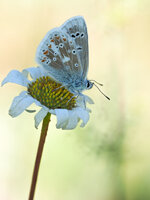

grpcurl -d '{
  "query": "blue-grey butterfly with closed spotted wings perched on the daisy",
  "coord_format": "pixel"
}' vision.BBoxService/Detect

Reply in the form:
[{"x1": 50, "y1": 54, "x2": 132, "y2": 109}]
[{"x1": 36, "y1": 16, "x2": 109, "y2": 100}]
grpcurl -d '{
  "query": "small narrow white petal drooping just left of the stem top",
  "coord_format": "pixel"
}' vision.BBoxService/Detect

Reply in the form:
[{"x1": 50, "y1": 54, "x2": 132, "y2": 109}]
[{"x1": 34, "y1": 106, "x2": 49, "y2": 128}]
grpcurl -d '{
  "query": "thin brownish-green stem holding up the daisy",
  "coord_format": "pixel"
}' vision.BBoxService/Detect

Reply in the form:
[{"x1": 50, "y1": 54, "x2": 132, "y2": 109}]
[{"x1": 29, "y1": 113, "x2": 51, "y2": 200}]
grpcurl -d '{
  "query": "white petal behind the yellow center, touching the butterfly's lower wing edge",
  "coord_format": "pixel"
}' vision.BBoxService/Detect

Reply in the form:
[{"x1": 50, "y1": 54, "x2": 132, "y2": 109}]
[{"x1": 22, "y1": 67, "x2": 46, "y2": 80}]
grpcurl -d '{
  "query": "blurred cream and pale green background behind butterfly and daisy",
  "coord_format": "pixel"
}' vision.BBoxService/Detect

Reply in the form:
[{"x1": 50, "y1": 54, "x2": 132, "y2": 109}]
[{"x1": 0, "y1": 0, "x2": 150, "y2": 200}]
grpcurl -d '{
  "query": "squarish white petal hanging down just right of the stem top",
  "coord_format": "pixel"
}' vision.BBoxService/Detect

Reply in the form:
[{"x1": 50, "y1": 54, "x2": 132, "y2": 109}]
[{"x1": 55, "y1": 109, "x2": 69, "y2": 128}]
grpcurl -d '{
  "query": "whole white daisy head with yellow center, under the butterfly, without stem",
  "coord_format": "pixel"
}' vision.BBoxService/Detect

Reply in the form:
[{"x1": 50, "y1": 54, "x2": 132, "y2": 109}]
[{"x1": 2, "y1": 67, "x2": 93, "y2": 129}]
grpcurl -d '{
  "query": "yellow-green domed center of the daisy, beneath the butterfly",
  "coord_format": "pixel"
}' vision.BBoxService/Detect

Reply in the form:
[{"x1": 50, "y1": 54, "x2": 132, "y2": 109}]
[{"x1": 28, "y1": 76, "x2": 76, "y2": 110}]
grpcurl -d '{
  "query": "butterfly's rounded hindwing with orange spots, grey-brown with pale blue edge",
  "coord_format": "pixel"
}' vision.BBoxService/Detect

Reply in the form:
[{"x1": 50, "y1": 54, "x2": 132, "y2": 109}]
[{"x1": 36, "y1": 28, "x2": 82, "y2": 85}]
